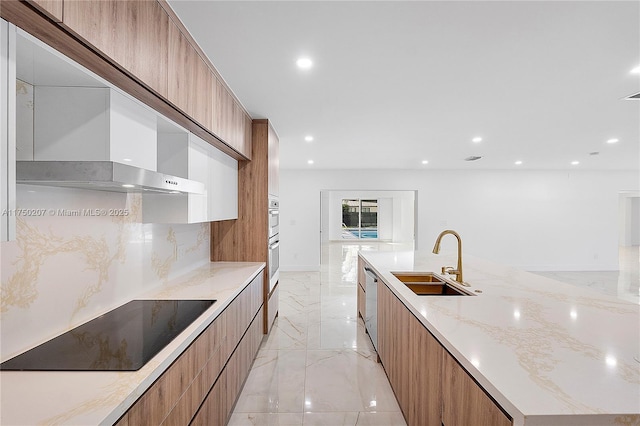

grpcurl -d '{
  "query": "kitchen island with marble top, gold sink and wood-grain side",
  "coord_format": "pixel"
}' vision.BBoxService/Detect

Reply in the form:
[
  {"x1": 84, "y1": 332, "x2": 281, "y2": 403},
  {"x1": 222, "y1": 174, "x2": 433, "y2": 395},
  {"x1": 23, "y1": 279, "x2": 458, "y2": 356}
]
[{"x1": 359, "y1": 251, "x2": 640, "y2": 426}]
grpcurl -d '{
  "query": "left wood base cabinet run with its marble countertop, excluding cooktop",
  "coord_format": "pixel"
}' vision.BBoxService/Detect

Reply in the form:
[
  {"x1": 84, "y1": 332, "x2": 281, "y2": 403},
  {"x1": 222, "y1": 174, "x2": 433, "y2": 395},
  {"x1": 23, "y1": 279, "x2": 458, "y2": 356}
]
[{"x1": 0, "y1": 262, "x2": 265, "y2": 425}]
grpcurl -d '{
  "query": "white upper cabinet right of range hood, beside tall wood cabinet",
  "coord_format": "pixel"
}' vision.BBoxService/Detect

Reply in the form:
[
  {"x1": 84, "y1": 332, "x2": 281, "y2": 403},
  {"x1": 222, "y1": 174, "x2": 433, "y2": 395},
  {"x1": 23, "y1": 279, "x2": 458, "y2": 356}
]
[{"x1": 142, "y1": 132, "x2": 238, "y2": 223}]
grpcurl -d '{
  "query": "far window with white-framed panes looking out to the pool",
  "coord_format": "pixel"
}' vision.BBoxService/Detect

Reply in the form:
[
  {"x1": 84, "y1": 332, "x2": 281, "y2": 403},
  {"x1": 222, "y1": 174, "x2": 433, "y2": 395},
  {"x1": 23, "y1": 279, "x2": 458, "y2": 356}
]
[{"x1": 341, "y1": 198, "x2": 378, "y2": 240}]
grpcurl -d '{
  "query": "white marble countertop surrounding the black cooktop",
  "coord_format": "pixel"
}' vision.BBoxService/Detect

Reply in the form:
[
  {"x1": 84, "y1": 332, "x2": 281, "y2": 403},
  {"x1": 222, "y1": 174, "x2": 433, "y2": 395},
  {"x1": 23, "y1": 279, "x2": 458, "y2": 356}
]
[{"x1": 0, "y1": 262, "x2": 265, "y2": 425}]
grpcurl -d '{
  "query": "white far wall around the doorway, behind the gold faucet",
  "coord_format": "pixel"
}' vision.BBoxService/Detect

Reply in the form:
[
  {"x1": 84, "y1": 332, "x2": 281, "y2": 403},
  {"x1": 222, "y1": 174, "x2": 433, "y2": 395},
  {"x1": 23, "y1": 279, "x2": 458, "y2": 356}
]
[{"x1": 280, "y1": 169, "x2": 640, "y2": 270}]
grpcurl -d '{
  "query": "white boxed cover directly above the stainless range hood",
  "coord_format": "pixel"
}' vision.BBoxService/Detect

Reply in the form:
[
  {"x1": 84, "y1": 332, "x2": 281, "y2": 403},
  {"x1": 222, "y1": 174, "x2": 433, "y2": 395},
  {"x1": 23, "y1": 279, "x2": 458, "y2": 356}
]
[{"x1": 34, "y1": 86, "x2": 156, "y2": 171}]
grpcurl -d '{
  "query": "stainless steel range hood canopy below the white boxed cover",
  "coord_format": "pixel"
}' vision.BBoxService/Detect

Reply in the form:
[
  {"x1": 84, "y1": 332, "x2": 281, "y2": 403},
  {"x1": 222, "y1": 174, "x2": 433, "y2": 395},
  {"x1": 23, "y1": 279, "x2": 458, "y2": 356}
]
[{"x1": 16, "y1": 161, "x2": 204, "y2": 194}]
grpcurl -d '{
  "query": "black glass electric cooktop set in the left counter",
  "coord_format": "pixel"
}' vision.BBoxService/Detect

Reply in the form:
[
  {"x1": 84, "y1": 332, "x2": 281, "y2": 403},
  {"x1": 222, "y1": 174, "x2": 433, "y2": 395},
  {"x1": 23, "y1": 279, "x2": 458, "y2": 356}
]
[{"x1": 0, "y1": 300, "x2": 215, "y2": 371}]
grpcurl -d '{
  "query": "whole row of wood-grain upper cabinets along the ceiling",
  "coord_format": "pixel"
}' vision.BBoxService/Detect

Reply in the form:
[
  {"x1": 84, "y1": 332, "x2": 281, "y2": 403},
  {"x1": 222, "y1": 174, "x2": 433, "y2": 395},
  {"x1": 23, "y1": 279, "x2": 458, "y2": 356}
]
[{"x1": 8, "y1": 0, "x2": 252, "y2": 160}]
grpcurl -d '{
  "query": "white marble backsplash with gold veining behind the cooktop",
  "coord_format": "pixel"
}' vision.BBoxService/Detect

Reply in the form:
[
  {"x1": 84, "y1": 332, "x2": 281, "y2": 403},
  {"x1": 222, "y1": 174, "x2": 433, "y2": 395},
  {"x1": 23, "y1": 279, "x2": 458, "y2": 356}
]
[{"x1": 0, "y1": 185, "x2": 210, "y2": 361}]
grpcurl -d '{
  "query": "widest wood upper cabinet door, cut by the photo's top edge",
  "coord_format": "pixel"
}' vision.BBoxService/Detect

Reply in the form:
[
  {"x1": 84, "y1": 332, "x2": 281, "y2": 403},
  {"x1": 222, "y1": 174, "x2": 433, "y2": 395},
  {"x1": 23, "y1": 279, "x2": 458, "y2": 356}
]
[{"x1": 62, "y1": 0, "x2": 170, "y2": 98}]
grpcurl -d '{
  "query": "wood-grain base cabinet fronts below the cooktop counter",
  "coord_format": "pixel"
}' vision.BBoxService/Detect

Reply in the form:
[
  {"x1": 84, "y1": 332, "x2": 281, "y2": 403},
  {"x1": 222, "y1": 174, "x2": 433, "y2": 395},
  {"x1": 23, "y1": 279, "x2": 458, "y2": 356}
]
[{"x1": 117, "y1": 274, "x2": 263, "y2": 426}]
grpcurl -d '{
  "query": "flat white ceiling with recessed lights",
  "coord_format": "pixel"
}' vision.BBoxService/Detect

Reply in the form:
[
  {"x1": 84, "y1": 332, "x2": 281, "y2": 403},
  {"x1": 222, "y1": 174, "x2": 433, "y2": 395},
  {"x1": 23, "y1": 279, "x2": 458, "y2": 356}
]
[{"x1": 170, "y1": 0, "x2": 640, "y2": 170}]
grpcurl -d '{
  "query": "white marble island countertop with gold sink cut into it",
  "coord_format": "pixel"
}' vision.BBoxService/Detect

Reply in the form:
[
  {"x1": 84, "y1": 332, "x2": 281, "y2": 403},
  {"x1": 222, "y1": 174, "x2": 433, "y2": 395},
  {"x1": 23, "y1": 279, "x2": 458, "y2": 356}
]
[{"x1": 360, "y1": 251, "x2": 640, "y2": 426}]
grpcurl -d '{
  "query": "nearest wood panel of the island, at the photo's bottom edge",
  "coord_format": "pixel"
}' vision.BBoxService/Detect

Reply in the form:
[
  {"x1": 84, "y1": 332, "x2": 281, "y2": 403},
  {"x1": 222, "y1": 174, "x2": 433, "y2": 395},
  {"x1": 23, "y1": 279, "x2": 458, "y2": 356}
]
[{"x1": 442, "y1": 352, "x2": 512, "y2": 426}]
